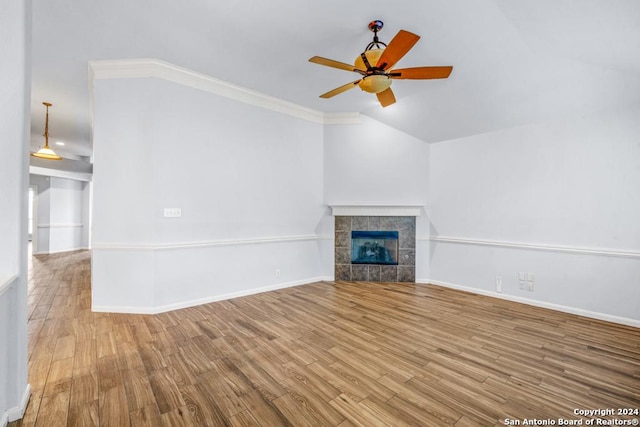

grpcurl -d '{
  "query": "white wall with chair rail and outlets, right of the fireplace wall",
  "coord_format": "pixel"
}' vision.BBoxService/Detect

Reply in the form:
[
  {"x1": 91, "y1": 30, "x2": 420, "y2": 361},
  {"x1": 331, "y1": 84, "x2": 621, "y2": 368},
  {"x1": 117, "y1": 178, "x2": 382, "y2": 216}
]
[{"x1": 430, "y1": 108, "x2": 640, "y2": 324}]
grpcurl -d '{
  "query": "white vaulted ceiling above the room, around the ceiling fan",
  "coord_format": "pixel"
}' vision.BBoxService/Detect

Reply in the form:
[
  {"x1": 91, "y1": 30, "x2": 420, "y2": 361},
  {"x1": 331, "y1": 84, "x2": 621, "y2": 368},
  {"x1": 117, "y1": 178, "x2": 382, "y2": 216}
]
[{"x1": 32, "y1": 0, "x2": 640, "y2": 159}]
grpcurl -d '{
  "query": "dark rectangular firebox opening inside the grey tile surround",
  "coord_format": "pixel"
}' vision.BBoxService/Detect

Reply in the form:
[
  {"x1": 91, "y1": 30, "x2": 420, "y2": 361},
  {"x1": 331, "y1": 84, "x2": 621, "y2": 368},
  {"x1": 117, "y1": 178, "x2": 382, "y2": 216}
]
[{"x1": 351, "y1": 231, "x2": 398, "y2": 265}]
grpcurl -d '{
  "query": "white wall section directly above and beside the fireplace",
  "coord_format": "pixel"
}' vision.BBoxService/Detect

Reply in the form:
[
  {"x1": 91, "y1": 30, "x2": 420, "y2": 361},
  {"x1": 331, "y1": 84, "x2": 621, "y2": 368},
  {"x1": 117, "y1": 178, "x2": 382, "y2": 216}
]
[{"x1": 324, "y1": 116, "x2": 429, "y2": 278}]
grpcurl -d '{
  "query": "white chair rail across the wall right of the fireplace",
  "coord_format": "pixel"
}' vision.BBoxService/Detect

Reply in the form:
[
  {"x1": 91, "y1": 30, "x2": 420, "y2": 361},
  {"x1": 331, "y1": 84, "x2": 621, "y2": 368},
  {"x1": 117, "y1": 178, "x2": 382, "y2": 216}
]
[{"x1": 429, "y1": 236, "x2": 640, "y2": 259}]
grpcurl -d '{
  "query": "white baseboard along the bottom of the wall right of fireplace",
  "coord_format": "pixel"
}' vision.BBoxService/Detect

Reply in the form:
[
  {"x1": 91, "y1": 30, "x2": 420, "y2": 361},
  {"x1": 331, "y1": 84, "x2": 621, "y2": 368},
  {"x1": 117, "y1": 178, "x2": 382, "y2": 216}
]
[{"x1": 416, "y1": 279, "x2": 640, "y2": 328}]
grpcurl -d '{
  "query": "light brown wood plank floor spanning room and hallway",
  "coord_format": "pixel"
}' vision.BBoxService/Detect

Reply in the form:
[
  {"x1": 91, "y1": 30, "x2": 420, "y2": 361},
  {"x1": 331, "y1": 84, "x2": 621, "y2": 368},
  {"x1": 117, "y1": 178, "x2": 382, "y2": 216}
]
[{"x1": 13, "y1": 252, "x2": 640, "y2": 427}]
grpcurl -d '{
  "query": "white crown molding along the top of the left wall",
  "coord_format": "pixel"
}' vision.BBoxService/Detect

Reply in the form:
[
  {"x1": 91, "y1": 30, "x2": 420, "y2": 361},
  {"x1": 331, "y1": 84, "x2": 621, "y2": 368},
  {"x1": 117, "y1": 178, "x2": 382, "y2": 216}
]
[{"x1": 89, "y1": 58, "x2": 360, "y2": 125}]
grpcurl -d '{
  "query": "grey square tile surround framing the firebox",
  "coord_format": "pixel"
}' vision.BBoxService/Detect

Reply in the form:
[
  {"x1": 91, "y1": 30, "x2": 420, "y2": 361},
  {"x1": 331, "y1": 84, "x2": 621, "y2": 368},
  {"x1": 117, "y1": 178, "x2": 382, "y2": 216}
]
[{"x1": 335, "y1": 215, "x2": 416, "y2": 282}]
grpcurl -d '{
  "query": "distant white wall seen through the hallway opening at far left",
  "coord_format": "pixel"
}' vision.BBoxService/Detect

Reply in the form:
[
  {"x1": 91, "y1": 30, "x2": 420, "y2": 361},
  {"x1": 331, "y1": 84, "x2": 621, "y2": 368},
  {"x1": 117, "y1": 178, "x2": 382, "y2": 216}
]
[{"x1": 29, "y1": 174, "x2": 90, "y2": 254}]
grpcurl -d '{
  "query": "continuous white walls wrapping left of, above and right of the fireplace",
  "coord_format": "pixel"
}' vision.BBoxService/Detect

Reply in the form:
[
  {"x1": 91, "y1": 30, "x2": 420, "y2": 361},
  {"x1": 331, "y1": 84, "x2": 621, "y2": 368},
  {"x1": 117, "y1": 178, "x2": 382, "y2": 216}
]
[{"x1": 93, "y1": 62, "x2": 640, "y2": 323}]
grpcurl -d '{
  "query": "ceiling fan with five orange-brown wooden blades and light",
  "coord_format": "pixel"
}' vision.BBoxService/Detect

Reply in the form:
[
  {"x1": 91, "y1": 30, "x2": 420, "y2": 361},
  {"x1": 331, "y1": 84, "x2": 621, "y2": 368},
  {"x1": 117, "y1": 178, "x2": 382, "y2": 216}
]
[{"x1": 309, "y1": 20, "x2": 453, "y2": 107}]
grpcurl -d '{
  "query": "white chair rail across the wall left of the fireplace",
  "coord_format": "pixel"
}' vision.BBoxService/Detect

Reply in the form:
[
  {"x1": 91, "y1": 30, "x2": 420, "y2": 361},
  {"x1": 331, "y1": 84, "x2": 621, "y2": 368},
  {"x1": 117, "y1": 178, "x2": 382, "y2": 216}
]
[{"x1": 91, "y1": 234, "x2": 322, "y2": 251}]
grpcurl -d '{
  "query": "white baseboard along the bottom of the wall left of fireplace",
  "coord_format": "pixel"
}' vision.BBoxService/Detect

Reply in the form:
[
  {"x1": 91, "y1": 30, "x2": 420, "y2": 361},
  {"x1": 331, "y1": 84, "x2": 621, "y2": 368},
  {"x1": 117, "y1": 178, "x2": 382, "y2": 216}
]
[{"x1": 91, "y1": 277, "x2": 333, "y2": 314}]
